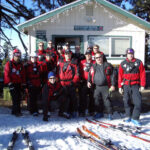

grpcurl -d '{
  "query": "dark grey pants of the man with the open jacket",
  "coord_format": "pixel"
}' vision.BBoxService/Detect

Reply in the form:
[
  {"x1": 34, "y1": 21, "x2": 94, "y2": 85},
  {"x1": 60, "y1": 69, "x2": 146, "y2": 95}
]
[{"x1": 94, "y1": 86, "x2": 112, "y2": 114}]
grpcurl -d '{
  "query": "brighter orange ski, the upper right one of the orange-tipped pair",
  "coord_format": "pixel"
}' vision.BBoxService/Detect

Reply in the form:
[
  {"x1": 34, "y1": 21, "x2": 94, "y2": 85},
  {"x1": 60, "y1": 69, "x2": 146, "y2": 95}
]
[{"x1": 82, "y1": 125, "x2": 127, "y2": 150}]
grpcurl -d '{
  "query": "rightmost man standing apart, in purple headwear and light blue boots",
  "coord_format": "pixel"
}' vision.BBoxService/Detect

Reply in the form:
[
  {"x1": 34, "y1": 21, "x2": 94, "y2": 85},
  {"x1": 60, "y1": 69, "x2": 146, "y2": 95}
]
[{"x1": 118, "y1": 48, "x2": 146, "y2": 126}]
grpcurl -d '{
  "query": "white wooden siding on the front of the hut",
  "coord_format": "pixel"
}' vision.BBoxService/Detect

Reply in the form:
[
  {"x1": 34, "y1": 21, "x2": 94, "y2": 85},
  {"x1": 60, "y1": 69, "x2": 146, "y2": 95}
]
[{"x1": 28, "y1": 3, "x2": 145, "y2": 63}]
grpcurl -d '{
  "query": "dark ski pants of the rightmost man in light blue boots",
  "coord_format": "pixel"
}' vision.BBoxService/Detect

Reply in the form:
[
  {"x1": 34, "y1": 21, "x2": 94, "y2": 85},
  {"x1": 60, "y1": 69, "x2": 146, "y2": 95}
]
[{"x1": 123, "y1": 85, "x2": 142, "y2": 120}]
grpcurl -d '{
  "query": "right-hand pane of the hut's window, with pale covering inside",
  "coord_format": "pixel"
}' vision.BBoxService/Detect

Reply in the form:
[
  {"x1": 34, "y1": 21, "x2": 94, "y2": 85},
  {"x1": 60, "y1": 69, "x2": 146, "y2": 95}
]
[{"x1": 111, "y1": 38, "x2": 130, "y2": 56}]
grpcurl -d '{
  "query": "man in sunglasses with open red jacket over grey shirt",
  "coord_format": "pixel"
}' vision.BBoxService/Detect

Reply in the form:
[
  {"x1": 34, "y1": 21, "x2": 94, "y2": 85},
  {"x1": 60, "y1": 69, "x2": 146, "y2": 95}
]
[{"x1": 87, "y1": 52, "x2": 115, "y2": 120}]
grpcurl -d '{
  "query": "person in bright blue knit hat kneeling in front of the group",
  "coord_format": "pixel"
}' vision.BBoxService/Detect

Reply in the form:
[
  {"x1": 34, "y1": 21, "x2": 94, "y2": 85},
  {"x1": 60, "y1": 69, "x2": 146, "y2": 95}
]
[{"x1": 42, "y1": 72, "x2": 63, "y2": 121}]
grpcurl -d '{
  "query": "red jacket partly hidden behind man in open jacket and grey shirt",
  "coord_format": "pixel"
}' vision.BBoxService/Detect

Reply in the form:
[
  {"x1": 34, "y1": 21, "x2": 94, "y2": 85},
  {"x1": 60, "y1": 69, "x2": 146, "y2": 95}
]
[{"x1": 80, "y1": 59, "x2": 95, "y2": 81}]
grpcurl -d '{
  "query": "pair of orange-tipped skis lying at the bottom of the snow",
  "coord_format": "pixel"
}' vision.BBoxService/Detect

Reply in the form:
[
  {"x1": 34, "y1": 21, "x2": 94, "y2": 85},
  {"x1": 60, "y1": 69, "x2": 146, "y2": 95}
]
[{"x1": 77, "y1": 125, "x2": 127, "y2": 150}]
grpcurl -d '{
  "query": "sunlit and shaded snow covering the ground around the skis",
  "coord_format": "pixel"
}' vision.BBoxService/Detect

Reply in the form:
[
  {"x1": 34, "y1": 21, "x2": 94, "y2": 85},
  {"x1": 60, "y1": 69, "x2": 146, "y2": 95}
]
[{"x1": 0, "y1": 107, "x2": 150, "y2": 150}]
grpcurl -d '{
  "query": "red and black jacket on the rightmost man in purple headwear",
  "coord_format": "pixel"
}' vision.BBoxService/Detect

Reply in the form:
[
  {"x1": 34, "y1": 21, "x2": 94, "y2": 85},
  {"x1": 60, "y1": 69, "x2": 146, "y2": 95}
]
[{"x1": 118, "y1": 58, "x2": 146, "y2": 88}]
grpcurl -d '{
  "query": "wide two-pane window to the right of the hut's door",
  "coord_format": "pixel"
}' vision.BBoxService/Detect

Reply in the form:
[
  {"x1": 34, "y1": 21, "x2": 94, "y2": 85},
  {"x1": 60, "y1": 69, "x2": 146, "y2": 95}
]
[{"x1": 88, "y1": 35, "x2": 132, "y2": 57}]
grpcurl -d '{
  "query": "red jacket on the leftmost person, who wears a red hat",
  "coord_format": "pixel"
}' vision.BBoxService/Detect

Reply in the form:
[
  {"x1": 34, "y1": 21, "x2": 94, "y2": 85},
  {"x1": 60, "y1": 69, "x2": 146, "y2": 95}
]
[{"x1": 4, "y1": 59, "x2": 25, "y2": 84}]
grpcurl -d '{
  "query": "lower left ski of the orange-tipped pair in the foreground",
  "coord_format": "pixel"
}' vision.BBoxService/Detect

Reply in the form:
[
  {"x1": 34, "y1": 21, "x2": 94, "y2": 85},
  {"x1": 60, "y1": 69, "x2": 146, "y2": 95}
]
[{"x1": 77, "y1": 128, "x2": 111, "y2": 150}]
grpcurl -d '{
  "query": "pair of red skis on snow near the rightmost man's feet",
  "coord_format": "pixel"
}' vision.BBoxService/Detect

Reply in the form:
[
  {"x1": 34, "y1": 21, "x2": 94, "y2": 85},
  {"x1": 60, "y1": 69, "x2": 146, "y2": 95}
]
[{"x1": 86, "y1": 119, "x2": 150, "y2": 143}]
